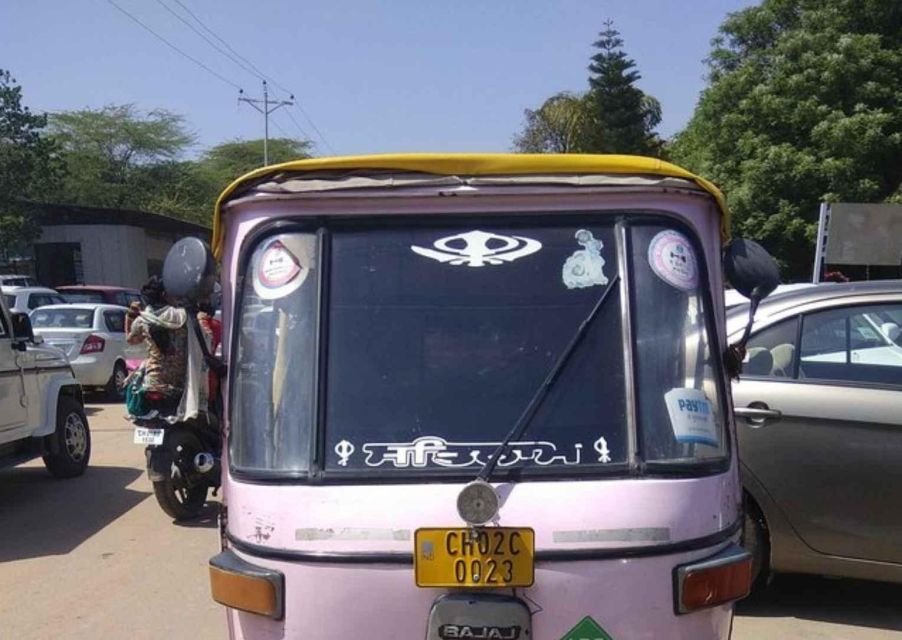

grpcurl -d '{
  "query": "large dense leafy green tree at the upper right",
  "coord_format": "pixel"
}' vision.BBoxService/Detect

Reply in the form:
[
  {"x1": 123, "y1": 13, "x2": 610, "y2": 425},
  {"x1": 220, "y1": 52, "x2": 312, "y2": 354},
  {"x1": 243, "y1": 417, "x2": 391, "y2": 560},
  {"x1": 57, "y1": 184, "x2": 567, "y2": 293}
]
[{"x1": 671, "y1": 0, "x2": 902, "y2": 278}]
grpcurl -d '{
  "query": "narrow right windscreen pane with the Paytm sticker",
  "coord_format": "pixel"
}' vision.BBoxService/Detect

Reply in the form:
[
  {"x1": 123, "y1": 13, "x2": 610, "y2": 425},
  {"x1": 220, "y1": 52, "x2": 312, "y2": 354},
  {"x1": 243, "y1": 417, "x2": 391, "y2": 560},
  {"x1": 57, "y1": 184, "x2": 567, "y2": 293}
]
[{"x1": 629, "y1": 224, "x2": 726, "y2": 463}]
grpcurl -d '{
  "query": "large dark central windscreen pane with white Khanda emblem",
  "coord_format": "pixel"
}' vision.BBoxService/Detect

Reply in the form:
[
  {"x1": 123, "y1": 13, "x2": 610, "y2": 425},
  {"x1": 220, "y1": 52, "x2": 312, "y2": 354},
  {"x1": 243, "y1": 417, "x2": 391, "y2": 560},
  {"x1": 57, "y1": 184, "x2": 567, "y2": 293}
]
[{"x1": 325, "y1": 219, "x2": 627, "y2": 477}]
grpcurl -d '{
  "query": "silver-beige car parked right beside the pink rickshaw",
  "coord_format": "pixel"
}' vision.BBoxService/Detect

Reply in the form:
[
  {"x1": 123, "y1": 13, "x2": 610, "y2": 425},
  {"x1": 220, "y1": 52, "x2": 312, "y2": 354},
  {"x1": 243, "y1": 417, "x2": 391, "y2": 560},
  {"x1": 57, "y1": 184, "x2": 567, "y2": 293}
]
[{"x1": 727, "y1": 280, "x2": 902, "y2": 582}]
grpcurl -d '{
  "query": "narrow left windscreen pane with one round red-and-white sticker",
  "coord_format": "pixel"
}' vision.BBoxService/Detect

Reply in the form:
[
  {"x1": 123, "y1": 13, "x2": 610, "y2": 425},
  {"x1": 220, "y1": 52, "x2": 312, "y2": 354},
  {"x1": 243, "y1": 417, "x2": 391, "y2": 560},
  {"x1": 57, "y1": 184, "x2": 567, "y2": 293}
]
[{"x1": 229, "y1": 233, "x2": 319, "y2": 472}]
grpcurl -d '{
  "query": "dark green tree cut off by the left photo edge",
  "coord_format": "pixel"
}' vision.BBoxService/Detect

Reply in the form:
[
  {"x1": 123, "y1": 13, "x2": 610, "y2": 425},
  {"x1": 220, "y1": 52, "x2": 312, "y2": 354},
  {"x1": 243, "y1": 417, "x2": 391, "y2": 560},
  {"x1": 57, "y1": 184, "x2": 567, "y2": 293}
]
[{"x1": 0, "y1": 69, "x2": 62, "y2": 253}]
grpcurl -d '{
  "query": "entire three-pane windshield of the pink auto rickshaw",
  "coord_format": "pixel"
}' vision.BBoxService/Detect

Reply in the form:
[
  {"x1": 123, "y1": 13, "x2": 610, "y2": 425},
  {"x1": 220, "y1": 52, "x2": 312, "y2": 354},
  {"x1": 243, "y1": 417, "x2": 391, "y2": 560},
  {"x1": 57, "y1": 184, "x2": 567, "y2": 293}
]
[{"x1": 230, "y1": 217, "x2": 724, "y2": 477}]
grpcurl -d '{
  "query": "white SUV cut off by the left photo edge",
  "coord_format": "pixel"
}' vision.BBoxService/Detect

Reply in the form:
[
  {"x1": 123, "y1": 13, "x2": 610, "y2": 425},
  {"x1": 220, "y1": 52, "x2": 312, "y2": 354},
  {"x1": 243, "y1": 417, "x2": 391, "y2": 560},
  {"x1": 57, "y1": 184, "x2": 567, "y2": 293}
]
[{"x1": 0, "y1": 296, "x2": 91, "y2": 478}]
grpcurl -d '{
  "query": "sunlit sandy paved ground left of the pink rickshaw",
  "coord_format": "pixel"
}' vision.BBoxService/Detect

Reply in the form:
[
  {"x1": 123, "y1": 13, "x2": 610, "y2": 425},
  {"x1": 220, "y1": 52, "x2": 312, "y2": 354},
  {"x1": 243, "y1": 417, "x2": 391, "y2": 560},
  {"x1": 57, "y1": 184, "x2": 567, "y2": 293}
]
[{"x1": 0, "y1": 405, "x2": 226, "y2": 640}]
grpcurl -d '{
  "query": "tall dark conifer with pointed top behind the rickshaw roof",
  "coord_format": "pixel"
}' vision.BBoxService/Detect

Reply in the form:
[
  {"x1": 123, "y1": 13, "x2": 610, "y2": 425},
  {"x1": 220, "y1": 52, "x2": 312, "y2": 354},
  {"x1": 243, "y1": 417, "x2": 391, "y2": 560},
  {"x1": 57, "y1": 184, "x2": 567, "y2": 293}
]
[{"x1": 589, "y1": 20, "x2": 661, "y2": 155}]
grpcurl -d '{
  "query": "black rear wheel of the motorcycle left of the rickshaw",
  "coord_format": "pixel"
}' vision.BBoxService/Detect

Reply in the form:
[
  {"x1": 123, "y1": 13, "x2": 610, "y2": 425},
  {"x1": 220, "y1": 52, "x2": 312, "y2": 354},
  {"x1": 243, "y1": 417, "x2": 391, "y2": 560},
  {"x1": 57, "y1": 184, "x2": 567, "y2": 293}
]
[{"x1": 153, "y1": 429, "x2": 208, "y2": 520}]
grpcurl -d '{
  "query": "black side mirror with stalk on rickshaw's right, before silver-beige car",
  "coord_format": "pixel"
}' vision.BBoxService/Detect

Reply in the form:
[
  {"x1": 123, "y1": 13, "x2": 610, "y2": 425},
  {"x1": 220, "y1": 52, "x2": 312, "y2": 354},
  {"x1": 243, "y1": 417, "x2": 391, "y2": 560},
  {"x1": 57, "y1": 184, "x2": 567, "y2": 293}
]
[{"x1": 723, "y1": 239, "x2": 780, "y2": 378}]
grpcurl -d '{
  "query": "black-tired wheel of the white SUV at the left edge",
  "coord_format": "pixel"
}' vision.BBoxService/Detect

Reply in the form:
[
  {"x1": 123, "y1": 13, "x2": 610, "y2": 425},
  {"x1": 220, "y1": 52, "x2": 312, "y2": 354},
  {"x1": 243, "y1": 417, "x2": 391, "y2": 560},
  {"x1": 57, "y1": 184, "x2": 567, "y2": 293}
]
[{"x1": 44, "y1": 396, "x2": 91, "y2": 478}]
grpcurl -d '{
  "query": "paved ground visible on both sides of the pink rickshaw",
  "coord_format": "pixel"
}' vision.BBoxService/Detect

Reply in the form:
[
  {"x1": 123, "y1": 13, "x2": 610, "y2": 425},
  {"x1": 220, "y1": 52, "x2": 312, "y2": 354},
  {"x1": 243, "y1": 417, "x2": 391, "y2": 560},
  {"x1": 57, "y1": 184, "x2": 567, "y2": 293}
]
[{"x1": 0, "y1": 405, "x2": 902, "y2": 640}]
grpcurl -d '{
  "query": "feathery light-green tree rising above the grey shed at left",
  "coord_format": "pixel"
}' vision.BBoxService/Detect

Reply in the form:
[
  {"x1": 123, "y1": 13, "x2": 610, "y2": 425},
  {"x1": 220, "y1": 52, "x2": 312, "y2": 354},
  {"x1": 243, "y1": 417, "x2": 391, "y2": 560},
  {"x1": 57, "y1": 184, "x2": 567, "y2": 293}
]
[{"x1": 50, "y1": 104, "x2": 194, "y2": 209}]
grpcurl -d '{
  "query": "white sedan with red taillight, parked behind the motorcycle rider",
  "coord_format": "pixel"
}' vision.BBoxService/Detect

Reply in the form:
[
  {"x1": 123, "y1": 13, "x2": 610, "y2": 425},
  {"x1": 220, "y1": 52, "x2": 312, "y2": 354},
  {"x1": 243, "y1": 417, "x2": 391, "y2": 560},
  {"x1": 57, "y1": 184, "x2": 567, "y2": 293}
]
[{"x1": 31, "y1": 304, "x2": 144, "y2": 400}]
